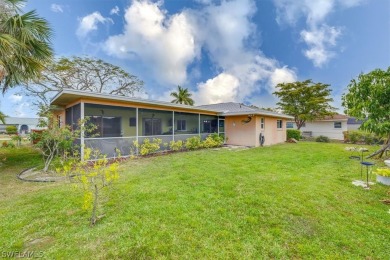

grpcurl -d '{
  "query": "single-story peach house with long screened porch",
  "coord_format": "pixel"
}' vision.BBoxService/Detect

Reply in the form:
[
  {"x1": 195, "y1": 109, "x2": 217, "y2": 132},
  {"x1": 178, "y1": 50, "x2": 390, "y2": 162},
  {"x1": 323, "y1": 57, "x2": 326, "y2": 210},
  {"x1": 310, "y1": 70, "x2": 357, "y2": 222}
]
[{"x1": 51, "y1": 89, "x2": 292, "y2": 157}]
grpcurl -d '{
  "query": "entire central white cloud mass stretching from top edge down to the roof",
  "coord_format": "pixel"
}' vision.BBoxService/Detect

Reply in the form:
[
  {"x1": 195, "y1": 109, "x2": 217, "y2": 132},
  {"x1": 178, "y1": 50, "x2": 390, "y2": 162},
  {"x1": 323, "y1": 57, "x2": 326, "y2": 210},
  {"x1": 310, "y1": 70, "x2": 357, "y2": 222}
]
[{"x1": 105, "y1": 0, "x2": 296, "y2": 104}]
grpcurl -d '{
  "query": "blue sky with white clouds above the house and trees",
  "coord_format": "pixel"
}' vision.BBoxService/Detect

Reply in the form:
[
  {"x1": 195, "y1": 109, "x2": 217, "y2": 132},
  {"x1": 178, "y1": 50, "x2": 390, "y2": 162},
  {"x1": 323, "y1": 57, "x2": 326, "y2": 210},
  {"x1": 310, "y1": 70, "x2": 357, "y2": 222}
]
[{"x1": 0, "y1": 0, "x2": 390, "y2": 117}]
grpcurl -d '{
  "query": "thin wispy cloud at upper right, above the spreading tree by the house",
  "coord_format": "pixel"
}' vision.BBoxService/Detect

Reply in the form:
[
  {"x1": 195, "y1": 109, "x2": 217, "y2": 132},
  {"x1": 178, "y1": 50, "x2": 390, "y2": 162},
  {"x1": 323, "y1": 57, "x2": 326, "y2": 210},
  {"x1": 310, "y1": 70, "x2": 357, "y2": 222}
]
[{"x1": 274, "y1": 0, "x2": 363, "y2": 67}]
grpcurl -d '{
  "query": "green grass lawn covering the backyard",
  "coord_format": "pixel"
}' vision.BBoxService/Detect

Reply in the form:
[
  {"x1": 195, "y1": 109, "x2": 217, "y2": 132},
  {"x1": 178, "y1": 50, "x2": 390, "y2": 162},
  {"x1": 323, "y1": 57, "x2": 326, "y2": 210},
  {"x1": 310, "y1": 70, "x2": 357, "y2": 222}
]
[{"x1": 0, "y1": 142, "x2": 390, "y2": 259}]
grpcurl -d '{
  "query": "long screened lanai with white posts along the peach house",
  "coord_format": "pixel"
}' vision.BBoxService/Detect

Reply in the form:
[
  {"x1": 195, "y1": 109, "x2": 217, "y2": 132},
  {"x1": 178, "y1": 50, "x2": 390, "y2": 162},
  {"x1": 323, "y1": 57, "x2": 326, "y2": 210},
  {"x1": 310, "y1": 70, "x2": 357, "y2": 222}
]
[{"x1": 66, "y1": 103, "x2": 225, "y2": 158}]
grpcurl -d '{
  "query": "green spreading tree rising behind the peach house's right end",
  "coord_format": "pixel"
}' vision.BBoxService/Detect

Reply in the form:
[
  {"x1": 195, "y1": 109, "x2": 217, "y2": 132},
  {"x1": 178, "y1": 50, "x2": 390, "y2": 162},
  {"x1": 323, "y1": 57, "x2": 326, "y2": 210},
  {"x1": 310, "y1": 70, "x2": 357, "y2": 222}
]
[{"x1": 273, "y1": 79, "x2": 335, "y2": 130}]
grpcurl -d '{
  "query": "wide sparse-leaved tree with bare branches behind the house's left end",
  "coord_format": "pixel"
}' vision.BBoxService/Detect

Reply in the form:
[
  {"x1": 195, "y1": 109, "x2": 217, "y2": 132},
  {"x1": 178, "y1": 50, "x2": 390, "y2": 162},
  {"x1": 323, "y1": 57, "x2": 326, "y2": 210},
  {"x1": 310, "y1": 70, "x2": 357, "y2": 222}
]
[{"x1": 25, "y1": 57, "x2": 143, "y2": 106}]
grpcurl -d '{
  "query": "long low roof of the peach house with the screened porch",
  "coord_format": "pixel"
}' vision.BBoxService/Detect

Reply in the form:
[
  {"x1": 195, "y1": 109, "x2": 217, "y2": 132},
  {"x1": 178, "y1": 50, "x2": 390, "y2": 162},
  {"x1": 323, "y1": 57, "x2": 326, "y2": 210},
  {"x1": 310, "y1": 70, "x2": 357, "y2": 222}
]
[{"x1": 51, "y1": 89, "x2": 293, "y2": 119}]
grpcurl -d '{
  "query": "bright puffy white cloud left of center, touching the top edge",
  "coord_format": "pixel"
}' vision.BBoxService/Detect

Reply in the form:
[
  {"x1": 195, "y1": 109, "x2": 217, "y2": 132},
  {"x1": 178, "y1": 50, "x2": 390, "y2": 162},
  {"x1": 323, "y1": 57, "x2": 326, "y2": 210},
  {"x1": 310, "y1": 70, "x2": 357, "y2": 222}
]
[{"x1": 105, "y1": 1, "x2": 199, "y2": 85}]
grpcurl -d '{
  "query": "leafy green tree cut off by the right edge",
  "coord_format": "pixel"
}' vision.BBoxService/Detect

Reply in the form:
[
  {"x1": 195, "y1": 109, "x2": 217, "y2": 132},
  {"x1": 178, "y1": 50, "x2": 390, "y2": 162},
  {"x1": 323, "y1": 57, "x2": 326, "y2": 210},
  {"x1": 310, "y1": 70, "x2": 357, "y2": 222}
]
[{"x1": 342, "y1": 67, "x2": 390, "y2": 157}]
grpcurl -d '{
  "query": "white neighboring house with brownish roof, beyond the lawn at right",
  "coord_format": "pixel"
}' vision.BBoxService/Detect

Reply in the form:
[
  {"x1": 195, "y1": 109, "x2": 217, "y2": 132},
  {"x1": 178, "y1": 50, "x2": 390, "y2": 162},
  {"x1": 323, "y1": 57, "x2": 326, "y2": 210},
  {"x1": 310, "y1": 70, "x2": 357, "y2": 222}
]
[{"x1": 287, "y1": 114, "x2": 348, "y2": 140}]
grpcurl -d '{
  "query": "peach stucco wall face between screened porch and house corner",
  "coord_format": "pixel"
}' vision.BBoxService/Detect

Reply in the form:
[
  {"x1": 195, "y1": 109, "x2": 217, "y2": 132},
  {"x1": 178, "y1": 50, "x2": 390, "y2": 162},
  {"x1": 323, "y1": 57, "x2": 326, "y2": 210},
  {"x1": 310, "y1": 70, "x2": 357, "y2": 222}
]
[{"x1": 225, "y1": 116, "x2": 259, "y2": 146}]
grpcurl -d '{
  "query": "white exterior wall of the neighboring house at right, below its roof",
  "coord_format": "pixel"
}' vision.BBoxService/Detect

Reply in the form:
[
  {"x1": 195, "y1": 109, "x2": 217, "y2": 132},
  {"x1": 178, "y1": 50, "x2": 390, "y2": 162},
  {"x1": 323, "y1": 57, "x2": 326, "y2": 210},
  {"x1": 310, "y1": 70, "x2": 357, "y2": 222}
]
[{"x1": 300, "y1": 120, "x2": 347, "y2": 140}]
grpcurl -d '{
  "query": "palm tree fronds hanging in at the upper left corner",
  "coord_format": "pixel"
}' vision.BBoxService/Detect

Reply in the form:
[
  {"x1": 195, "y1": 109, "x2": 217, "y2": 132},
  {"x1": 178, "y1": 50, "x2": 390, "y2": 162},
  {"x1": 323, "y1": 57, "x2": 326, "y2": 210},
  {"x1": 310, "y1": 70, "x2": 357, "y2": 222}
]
[{"x1": 0, "y1": 0, "x2": 53, "y2": 94}]
